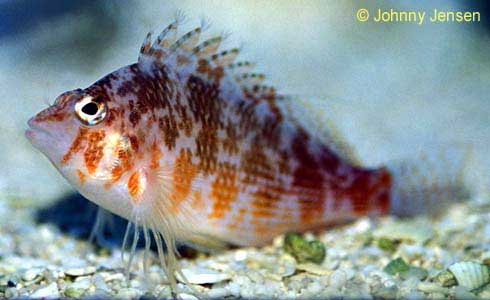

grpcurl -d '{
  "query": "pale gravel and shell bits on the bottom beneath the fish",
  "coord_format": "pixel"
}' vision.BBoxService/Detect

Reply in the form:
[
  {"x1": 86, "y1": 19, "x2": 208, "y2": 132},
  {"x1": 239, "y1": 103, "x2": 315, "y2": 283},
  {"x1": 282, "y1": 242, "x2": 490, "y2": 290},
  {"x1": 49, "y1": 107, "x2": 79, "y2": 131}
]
[{"x1": 0, "y1": 193, "x2": 490, "y2": 299}]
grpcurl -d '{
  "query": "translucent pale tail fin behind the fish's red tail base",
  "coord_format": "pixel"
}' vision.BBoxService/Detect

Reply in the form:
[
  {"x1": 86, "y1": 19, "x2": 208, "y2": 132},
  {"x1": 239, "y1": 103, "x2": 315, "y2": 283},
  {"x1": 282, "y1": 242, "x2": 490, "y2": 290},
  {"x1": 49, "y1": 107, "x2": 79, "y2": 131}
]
[{"x1": 387, "y1": 145, "x2": 472, "y2": 216}]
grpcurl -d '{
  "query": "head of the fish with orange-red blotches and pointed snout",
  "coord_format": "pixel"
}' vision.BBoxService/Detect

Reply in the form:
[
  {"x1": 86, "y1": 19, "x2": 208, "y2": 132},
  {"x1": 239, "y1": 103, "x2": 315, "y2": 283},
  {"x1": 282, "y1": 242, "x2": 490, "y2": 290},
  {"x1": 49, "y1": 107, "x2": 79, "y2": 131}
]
[{"x1": 25, "y1": 77, "x2": 143, "y2": 216}]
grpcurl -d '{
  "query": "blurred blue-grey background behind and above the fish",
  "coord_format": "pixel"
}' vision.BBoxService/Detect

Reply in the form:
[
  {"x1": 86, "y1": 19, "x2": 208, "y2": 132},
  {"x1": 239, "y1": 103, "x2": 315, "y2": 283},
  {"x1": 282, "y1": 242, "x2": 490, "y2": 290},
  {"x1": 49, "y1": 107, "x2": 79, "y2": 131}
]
[{"x1": 0, "y1": 0, "x2": 490, "y2": 206}]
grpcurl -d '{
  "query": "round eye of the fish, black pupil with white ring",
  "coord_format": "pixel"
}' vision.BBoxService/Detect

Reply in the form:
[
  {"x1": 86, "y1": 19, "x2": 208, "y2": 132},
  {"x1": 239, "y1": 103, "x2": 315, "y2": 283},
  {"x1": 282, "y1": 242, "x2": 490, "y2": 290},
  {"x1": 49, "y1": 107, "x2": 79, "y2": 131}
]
[{"x1": 75, "y1": 96, "x2": 107, "y2": 126}]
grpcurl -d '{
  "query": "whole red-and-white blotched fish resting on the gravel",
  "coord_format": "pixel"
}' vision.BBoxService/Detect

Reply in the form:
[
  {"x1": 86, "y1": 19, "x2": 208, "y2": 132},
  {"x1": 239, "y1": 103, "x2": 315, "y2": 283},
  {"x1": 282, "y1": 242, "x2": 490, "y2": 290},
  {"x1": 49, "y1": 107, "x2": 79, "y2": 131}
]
[{"x1": 26, "y1": 18, "x2": 467, "y2": 284}]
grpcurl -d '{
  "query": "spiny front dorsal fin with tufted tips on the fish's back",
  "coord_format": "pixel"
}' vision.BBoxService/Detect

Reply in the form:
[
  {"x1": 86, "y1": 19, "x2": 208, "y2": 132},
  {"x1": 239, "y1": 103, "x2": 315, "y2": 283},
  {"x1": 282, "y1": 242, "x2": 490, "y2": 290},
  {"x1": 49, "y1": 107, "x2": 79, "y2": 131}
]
[{"x1": 138, "y1": 18, "x2": 280, "y2": 101}]
